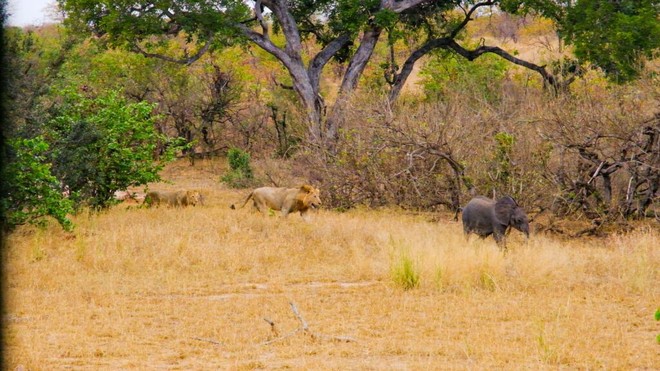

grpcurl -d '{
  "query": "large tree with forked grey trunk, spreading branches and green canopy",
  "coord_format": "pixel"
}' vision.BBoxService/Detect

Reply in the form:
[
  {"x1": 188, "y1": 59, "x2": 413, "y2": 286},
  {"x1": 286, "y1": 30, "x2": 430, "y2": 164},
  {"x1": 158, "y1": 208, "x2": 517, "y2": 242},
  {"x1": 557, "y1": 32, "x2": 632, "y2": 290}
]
[{"x1": 58, "y1": 0, "x2": 660, "y2": 142}]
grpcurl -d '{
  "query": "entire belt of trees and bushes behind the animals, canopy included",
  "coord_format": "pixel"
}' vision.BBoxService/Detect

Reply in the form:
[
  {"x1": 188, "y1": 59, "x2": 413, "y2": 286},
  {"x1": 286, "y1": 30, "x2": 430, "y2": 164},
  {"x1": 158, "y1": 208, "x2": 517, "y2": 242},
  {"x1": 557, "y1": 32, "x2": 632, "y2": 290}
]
[{"x1": 2, "y1": 0, "x2": 660, "y2": 232}]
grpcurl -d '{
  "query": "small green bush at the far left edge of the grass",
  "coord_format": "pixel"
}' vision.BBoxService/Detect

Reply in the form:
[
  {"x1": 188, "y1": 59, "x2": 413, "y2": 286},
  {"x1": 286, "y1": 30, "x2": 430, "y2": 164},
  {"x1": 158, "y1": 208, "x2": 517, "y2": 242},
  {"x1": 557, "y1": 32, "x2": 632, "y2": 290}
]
[{"x1": 0, "y1": 137, "x2": 73, "y2": 230}]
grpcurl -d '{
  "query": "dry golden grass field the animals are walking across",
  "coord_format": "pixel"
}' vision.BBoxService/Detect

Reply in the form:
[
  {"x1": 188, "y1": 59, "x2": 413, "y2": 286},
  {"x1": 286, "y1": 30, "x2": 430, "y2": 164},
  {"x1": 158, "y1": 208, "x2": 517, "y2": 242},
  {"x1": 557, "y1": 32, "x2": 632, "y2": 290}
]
[{"x1": 3, "y1": 161, "x2": 660, "y2": 370}]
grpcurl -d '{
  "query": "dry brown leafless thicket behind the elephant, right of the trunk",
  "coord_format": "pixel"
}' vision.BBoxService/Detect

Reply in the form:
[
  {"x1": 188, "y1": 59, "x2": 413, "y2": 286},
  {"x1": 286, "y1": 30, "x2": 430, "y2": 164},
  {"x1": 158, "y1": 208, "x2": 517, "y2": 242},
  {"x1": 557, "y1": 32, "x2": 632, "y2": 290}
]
[{"x1": 298, "y1": 72, "x2": 660, "y2": 225}]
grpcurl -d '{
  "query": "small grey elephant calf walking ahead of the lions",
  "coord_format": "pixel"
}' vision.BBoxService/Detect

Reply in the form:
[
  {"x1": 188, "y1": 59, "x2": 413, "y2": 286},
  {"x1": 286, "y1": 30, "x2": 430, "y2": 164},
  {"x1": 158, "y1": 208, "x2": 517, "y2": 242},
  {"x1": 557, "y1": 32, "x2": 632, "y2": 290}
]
[{"x1": 463, "y1": 196, "x2": 529, "y2": 249}]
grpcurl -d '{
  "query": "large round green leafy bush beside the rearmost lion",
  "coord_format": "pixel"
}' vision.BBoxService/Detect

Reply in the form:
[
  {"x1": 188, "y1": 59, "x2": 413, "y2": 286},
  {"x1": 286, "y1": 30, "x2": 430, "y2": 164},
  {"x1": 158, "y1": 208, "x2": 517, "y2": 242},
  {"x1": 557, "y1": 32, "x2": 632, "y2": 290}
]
[{"x1": 49, "y1": 91, "x2": 179, "y2": 210}]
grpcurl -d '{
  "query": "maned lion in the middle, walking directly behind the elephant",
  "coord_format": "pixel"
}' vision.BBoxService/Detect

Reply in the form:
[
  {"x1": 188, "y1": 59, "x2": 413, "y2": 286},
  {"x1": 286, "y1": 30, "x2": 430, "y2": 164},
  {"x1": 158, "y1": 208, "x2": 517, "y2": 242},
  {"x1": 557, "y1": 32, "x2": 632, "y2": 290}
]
[{"x1": 231, "y1": 184, "x2": 321, "y2": 219}]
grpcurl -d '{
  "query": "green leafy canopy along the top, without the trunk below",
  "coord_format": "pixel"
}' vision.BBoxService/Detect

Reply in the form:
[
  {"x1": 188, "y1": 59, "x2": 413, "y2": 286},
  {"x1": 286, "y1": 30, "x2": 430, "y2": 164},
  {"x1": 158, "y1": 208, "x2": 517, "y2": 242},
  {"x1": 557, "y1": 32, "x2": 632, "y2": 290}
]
[{"x1": 58, "y1": 0, "x2": 660, "y2": 79}]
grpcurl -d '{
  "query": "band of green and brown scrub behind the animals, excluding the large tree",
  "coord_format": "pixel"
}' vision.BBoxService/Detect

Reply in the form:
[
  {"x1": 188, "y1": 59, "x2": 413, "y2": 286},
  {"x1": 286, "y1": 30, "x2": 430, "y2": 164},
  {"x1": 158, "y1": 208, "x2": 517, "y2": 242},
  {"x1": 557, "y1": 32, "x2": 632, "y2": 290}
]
[{"x1": 7, "y1": 4, "x2": 660, "y2": 233}]
